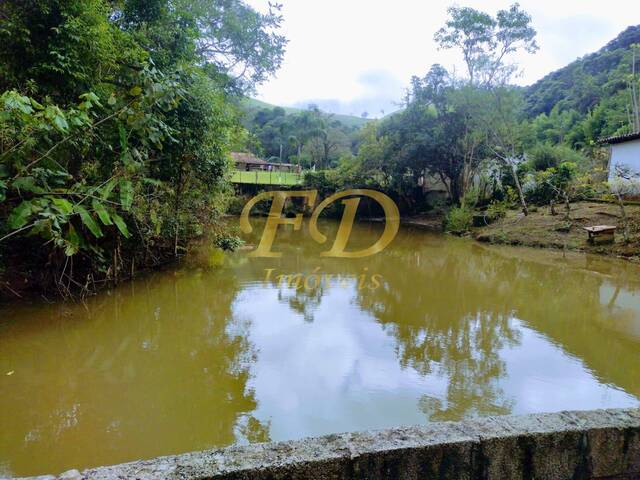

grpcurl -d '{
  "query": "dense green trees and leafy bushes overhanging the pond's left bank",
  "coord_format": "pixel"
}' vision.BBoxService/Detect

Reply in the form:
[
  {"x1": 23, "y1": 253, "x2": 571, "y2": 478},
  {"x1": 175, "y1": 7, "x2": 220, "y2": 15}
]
[{"x1": 0, "y1": 0, "x2": 286, "y2": 293}]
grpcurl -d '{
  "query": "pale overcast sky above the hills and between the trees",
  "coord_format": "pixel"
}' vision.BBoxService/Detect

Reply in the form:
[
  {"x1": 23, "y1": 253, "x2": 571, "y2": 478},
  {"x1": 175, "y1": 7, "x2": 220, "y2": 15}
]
[{"x1": 247, "y1": 0, "x2": 640, "y2": 117}]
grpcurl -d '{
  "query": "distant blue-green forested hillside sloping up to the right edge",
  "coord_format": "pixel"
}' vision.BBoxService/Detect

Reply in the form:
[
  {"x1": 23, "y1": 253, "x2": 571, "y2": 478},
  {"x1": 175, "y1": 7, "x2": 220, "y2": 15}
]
[{"x1": 525, "y1": 25, "x2": 640, "y2": 116}]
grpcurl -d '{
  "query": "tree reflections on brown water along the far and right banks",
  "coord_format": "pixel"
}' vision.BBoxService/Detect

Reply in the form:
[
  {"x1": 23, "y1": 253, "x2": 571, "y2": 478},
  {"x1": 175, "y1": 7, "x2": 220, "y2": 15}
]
[{"x1": 231, "y1": 218, "x2": 640, "y2": 418}]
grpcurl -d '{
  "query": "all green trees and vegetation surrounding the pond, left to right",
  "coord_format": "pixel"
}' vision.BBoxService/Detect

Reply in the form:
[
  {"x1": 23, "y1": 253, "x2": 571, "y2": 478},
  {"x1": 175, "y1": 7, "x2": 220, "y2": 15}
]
[{"x1": 0, "y1": 0, "x2": 640, "y2": 295}]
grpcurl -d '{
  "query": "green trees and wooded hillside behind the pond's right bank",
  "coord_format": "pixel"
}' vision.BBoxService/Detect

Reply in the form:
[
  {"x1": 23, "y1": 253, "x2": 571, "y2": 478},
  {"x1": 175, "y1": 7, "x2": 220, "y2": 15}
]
[{"x1": 320, "y1": 8, "x2": 640, "y2": 219}]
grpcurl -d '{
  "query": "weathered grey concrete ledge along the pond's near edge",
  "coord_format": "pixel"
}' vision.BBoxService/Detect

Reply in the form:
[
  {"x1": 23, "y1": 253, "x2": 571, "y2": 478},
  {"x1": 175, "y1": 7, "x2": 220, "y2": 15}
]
[{"x1": 23, "y1": 409, "x2": 640, "y2": 480}]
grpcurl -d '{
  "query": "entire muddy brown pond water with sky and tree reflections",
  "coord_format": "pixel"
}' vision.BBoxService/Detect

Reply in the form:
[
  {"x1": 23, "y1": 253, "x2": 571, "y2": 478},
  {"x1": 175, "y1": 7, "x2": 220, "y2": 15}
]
[{"x1": 0, "y1": 222, "x2": 640, "y2": 477}]
